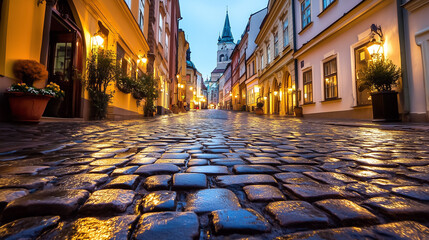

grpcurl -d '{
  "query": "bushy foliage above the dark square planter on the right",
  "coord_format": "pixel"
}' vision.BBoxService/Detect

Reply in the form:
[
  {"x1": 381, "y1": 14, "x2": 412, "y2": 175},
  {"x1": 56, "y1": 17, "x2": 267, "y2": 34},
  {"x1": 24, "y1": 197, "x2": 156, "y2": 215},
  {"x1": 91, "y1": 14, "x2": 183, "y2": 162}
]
[{"x1": 358, "y1": 58, "x2": 401, "y2": 92}]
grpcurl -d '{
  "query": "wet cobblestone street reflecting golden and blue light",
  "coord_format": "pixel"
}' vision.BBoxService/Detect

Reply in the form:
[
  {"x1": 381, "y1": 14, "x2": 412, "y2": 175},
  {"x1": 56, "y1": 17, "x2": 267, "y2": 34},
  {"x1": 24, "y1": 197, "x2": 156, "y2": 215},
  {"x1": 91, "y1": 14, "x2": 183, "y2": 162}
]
[{"x1": 0, "y1": 110, "x2": 429, "y2": 240}]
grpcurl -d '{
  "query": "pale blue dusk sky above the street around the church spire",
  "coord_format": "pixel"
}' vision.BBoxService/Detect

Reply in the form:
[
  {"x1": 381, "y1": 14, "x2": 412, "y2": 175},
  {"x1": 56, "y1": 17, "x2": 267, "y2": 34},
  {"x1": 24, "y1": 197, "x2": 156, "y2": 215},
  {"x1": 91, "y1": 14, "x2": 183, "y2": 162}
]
[{"x1": 180, "y1": 0, "x2": 268, "y2": 79}]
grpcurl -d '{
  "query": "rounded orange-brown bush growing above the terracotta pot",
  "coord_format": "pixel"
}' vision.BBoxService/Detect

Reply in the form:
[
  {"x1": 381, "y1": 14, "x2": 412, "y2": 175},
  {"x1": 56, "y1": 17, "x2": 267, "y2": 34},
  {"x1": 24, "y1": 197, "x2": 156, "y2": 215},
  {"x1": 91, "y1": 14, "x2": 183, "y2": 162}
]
[{"x1": 13, "y1": 59, "x2": 48, "y2": 87}]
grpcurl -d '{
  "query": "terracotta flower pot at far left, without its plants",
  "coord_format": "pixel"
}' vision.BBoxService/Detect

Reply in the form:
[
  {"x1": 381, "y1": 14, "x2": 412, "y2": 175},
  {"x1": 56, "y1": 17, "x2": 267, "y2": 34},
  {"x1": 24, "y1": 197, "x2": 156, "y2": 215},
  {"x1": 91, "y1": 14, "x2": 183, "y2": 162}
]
[{"x1": 6, "y1": 92, "x2": 52, "y2": 122}]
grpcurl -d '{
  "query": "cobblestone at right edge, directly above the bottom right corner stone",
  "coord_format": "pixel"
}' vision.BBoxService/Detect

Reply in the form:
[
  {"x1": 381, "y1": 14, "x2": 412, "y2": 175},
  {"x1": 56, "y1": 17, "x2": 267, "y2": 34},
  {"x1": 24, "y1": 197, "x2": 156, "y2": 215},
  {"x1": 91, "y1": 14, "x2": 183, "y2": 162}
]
[{"x1": 364, "y1": 196, "x2": 429, "y2": 219}]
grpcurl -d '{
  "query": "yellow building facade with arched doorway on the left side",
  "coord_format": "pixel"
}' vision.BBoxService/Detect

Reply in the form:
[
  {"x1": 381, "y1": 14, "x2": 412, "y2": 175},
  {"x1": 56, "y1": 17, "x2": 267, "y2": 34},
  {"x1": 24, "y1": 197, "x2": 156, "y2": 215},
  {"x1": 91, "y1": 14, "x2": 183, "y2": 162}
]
[{"x1": 0, "y1": 0, "x2": 149, "y2": 119}]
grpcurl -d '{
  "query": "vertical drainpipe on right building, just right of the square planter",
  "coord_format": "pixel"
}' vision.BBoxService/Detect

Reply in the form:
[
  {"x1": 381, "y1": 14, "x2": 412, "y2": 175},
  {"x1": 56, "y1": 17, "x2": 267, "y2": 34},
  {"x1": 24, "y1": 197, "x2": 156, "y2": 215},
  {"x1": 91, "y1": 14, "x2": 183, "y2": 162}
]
[{"x1": 396, "y1": 0, "x2": 410, "y2": 122}]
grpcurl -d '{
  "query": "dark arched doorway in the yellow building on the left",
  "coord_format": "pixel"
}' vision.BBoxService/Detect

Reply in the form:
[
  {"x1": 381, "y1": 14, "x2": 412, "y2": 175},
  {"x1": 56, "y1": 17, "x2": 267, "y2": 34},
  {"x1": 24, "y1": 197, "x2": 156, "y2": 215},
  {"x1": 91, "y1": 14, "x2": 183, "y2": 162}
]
[{"x1": 47, "y1": 1, "x2": 84, "y2": 118}]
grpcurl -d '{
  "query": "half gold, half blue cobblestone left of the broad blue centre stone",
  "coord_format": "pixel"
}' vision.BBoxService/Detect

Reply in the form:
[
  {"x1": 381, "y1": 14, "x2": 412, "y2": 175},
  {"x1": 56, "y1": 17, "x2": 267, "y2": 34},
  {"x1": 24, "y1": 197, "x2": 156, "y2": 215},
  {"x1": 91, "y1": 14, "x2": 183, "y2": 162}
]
[{"x1": 141, "y1": 191, "x2": 177, "y2": 212}]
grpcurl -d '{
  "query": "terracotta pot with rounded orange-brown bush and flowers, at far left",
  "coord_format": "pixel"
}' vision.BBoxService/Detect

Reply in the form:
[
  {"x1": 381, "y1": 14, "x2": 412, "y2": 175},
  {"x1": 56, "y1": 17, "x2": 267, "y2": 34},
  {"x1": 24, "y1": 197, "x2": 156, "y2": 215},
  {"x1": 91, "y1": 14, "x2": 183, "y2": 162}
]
[{"x1": 5, "y1": 60, "x2": 55, "y2": 122}]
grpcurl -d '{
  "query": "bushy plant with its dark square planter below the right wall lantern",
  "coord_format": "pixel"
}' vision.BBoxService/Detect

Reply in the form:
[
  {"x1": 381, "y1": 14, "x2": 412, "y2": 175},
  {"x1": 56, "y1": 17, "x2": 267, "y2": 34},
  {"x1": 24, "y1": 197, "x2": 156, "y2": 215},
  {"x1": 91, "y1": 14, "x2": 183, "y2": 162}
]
[{"x1": 358, "y1": 58, "x2": 401, "y2": 121}]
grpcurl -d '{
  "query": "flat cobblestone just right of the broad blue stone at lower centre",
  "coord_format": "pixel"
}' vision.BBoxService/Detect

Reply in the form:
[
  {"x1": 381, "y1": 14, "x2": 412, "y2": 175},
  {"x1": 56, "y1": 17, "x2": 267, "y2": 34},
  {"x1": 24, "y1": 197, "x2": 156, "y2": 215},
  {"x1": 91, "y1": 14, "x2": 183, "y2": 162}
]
[{"x1": 243, "y1": 185, "x2": 286, "y2": 202}]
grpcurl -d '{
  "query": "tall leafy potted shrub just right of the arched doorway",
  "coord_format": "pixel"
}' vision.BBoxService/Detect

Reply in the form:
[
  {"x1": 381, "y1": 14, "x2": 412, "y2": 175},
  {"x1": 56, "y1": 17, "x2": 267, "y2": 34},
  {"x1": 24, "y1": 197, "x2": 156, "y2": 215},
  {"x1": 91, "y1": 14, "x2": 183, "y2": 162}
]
[{"x1": 84, "y1": 49, "x2": 117, "y2": 120}]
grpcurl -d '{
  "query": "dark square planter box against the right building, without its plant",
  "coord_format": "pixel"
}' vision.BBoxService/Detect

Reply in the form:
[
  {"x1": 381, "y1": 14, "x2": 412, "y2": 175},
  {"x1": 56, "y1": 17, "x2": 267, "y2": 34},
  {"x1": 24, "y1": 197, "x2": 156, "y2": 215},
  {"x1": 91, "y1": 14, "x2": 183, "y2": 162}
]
[{"x1": 371, "y1": 91, "x2": 400, "y2": 122}]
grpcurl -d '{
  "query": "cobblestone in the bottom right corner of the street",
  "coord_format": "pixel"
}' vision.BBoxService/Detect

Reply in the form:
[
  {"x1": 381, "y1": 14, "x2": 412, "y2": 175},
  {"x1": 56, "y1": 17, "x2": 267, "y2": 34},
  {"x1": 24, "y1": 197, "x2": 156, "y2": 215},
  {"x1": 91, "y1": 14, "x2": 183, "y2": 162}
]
[{"x1": 373, "y1": 221, "x2": 429, "y2": 240}]
